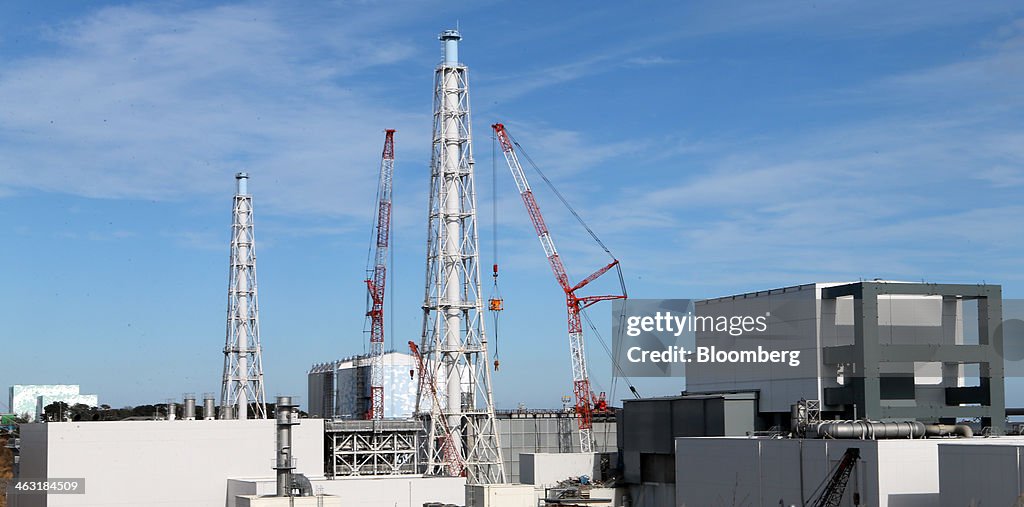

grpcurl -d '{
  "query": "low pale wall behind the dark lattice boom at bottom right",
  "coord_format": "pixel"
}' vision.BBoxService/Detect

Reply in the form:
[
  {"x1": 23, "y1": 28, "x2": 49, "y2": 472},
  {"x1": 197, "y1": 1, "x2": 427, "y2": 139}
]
[{"x1": 676, "y1": 437, "x2": 946, "y2": 507}]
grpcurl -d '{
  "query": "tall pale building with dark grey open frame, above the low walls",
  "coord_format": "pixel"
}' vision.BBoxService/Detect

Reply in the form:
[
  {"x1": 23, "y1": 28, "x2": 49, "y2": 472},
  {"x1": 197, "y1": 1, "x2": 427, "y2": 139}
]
[{"x1": 686, "y1": 282, "x2": 1006, "y2": 431}]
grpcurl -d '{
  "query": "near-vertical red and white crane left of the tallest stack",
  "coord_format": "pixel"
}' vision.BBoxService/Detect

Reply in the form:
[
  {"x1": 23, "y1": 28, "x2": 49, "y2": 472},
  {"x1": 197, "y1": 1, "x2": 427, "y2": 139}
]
[{"x1": 367, "y1": 129, "x2": 394, "y2": 419}]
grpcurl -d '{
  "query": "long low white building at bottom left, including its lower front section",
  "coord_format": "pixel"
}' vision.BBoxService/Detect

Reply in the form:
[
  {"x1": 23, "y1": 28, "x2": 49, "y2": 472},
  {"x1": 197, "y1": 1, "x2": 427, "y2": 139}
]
[{"x1": 8, "y1": 419, "x2": 465, "y2": 507}]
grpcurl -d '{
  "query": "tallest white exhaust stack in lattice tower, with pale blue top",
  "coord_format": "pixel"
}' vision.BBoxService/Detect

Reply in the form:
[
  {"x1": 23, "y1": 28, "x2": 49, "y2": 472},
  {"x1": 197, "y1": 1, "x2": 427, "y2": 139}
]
[{"x1": 416, "y1": 30, "x2": 505, "y2": 484}]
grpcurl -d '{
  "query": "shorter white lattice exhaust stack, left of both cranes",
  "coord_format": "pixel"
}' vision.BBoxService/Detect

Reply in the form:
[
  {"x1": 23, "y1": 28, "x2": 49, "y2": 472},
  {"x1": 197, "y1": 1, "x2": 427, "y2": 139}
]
[{"x1": 220, "y1": 172, "x2": 266, "y2": 419}]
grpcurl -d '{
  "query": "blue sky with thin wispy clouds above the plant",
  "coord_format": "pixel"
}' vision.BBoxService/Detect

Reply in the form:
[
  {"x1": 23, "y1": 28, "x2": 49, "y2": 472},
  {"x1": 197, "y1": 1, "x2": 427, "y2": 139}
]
[{"x1": 0, "y1": 1, "x2": 1024, "y2": 409}]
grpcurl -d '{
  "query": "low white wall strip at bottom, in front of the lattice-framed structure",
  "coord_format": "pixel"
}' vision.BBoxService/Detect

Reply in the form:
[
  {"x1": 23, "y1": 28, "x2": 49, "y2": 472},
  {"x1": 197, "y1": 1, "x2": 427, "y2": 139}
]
[{"x1": 228, "y1": 476, "x2": 466, "y2": 507}]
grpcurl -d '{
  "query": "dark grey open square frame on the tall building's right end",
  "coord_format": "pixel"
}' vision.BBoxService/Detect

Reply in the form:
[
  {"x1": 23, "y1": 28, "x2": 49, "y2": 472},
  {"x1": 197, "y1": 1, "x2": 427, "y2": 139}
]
[{"x1": 821, "y1": 282, "x2": 1006, "y2": 433}]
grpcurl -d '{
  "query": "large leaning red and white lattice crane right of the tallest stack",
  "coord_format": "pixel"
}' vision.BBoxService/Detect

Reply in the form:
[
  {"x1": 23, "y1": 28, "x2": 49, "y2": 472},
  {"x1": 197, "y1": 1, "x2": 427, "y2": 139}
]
[{"x1": 492, "y1": 123, "x2": 626, "y2": 453}]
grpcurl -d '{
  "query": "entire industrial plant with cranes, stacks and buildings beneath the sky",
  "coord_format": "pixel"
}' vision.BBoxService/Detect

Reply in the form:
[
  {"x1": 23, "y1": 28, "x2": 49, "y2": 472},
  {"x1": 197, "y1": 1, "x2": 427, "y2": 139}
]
[{"x1": 0, "y1": 23, "x2": 1024, "y2": 507}]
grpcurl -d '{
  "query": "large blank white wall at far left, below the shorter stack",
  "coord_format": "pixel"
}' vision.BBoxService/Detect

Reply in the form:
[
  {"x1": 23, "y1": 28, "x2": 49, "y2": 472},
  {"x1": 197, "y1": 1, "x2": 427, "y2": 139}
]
[{"x1": 14, "y1": 419, "x2": 324, "y2": 507}]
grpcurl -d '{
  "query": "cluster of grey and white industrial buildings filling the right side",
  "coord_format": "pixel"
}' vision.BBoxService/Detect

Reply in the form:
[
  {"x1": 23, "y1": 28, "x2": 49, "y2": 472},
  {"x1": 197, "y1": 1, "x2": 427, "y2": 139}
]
[{"x1": 618, "y1": 281, "x2": 1024, "y2": 507}]
